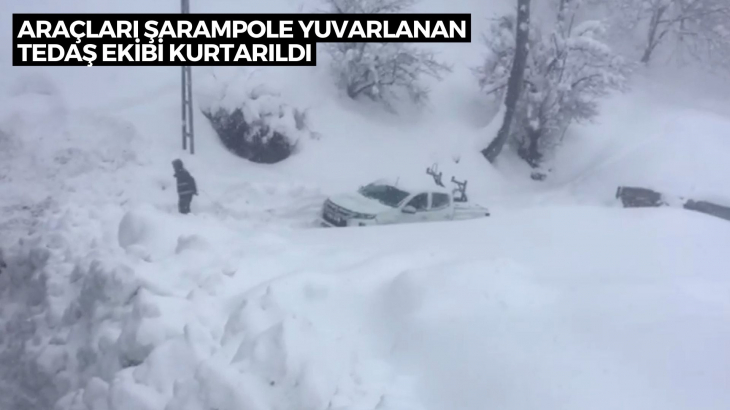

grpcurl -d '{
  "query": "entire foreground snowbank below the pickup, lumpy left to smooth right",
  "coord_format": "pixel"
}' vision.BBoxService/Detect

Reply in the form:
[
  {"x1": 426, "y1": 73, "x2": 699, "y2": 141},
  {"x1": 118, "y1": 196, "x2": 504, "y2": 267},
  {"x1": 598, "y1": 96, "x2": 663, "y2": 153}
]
[{"x1": 7, "y1": 199, "x2": 730, "y2": 410}]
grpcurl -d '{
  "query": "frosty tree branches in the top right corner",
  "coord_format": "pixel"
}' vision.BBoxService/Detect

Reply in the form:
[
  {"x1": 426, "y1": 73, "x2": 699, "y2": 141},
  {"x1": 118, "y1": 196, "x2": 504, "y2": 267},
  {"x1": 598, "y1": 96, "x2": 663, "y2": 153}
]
[{"x1": 592, "y1": 0, "x2": 730, "y2": 66}]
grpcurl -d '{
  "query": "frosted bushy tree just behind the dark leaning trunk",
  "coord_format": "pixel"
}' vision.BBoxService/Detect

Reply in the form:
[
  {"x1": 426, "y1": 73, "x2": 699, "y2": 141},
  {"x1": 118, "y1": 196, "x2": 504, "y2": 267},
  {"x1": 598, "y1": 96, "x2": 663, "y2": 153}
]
[{"x1": 476, "y1": 0, "x2": 630, "y2": 167}]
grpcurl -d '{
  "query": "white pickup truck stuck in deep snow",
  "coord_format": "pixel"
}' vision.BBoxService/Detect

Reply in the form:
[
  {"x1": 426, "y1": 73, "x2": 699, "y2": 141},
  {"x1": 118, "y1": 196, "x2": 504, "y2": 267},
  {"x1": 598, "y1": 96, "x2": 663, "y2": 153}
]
[{"x1": 321, "y1": 167, "x2": 489, "y2": 227}]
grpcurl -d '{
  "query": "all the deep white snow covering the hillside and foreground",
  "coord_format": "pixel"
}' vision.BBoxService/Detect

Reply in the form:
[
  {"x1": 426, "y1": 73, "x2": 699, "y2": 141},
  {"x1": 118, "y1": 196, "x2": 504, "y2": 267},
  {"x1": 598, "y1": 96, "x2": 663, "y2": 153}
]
[{"x1": 0, "y1": 0, "x2": 730, "y2": 410}]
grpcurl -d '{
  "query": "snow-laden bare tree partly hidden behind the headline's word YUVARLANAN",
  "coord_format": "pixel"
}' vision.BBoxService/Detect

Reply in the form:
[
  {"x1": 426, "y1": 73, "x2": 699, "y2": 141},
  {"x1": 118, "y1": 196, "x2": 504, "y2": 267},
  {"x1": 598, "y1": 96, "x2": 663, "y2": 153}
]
[{"x1": 325, "y1": 0, "x2": 451, "y2": 107}]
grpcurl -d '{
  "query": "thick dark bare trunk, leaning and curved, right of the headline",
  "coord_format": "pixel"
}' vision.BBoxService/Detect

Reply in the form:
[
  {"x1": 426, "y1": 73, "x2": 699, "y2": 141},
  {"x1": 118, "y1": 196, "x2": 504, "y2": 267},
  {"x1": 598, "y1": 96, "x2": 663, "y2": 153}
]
[{"x1": 482, "y1": 0, "x2": 530, "y2": 163}]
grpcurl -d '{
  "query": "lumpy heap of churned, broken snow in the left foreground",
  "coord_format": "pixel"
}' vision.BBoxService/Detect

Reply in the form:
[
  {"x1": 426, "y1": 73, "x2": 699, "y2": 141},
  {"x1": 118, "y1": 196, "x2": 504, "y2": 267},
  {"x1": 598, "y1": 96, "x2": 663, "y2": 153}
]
[{"x1": 0, "y1": 203, "x2": 420, "y2": 409}]
